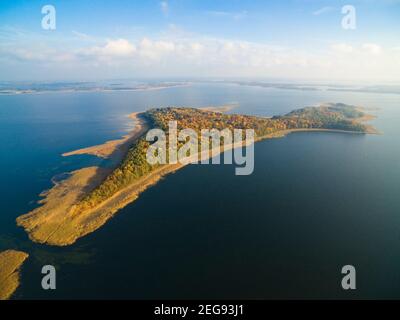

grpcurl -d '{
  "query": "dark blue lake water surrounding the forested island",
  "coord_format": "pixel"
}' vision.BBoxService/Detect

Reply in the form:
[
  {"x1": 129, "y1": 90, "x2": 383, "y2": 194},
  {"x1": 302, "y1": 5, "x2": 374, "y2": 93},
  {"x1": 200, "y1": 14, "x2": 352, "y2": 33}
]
[{"x1": 0, "y1": 84, "x2": 400, "y2": 299}]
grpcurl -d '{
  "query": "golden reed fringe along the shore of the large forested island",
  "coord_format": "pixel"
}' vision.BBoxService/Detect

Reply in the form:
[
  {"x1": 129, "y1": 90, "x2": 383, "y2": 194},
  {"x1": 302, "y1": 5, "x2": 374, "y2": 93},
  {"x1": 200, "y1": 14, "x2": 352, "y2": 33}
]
[{"x1": 17, "y1": 112, "x2": 375, "y2": 246}]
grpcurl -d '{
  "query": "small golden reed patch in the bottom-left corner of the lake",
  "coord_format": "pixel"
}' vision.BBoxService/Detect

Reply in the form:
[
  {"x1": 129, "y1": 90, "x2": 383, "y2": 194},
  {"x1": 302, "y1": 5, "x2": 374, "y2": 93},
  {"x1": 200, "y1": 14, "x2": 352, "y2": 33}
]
[{"x1": 0, "y1": 250, "x2": 28, "y2": 300}]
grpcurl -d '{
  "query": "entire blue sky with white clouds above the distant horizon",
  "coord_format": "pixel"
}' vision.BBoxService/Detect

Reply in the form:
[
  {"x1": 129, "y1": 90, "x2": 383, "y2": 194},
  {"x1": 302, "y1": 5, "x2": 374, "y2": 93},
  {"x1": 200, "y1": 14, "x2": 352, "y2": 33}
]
[{"x1": 0, "y1": 0, "x2": 400, "y2": 83}]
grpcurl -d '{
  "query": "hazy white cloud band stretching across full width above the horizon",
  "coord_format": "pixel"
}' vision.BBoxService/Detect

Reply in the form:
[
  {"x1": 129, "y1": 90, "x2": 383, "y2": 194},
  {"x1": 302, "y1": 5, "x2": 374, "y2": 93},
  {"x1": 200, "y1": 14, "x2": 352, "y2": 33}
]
[{"x1": 0, "y1": 31, "x2": 400, "y2": 80}]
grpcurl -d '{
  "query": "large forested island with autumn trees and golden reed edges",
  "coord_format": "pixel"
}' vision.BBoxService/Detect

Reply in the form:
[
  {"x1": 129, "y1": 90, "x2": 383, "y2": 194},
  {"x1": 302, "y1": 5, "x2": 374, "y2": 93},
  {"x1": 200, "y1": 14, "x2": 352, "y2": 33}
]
[{"x1": 17, "y1": 103, "x2": 377, "y2": 246}]
